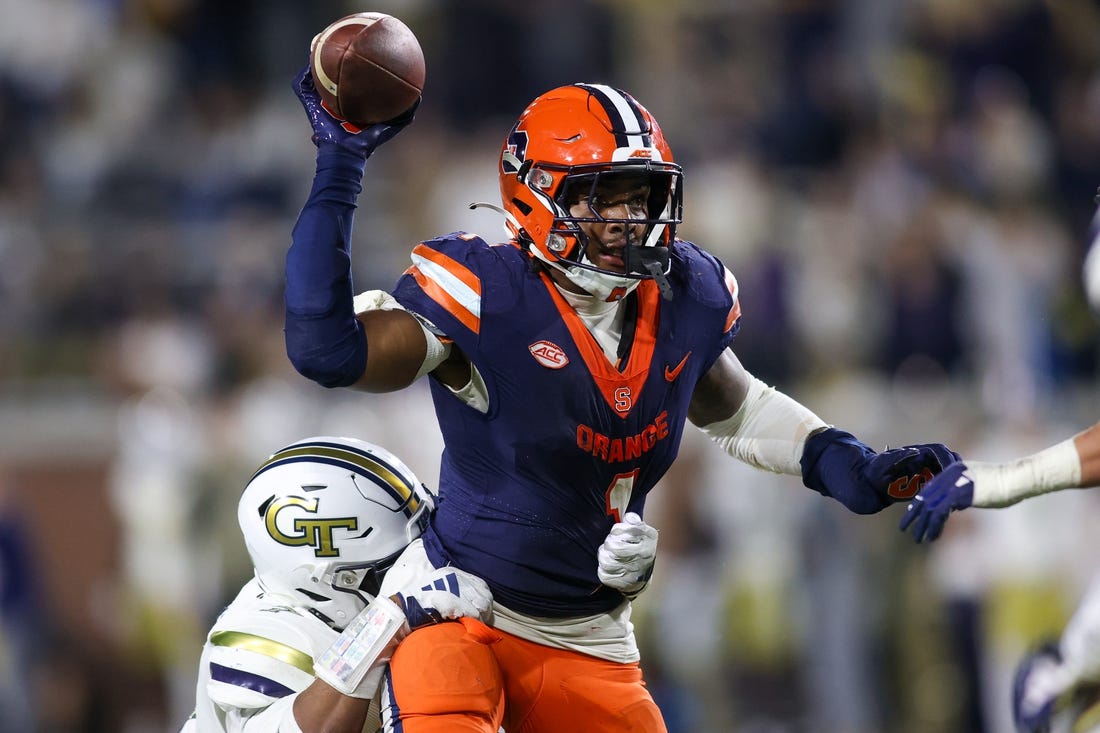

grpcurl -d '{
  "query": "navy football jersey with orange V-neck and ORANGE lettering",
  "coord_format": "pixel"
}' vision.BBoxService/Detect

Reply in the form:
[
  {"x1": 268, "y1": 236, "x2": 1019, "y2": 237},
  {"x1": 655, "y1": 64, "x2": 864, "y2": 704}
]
[{"x1": 394, "y1": 233, "x2": 740, "y2": 617}]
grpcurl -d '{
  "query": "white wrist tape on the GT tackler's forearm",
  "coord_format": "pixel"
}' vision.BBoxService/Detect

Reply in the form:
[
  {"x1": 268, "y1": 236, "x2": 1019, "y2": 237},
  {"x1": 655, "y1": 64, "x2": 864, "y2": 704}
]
[{"x1": 314, "y1": 597, "x2": 405, "y2": 699}]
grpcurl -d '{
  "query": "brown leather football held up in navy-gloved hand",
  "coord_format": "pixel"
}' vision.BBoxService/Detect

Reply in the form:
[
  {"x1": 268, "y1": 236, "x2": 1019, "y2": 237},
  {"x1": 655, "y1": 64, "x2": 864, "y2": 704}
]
[{"x1": 309, "y1": 12, "x2": 425, "y2": 128}]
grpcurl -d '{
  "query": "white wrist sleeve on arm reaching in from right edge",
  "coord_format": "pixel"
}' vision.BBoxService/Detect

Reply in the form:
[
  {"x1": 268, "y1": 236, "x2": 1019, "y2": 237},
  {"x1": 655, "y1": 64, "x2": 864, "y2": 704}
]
[{"x1": 966, "y1": 438, "x2": 1081, "y2": 507}]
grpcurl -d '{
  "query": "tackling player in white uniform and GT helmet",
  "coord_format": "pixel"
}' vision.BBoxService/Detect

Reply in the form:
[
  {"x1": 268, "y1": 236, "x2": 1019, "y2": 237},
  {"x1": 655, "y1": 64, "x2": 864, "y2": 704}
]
[{"x1": 182, "y1": 437, "x2": 492, "y2": 733}]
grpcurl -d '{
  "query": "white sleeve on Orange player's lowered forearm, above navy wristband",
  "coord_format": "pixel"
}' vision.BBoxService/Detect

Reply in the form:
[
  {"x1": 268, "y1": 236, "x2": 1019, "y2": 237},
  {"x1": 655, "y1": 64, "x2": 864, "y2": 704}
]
[{"x1": 701, "y1": 376, "x2": 828, "y2": 475}]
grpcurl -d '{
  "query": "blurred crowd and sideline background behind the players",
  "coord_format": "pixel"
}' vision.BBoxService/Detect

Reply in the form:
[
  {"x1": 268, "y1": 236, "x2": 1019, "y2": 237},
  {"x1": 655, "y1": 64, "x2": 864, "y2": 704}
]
[{"x1": 0, "y1": 0, "x2": 1100, "y2": 733}]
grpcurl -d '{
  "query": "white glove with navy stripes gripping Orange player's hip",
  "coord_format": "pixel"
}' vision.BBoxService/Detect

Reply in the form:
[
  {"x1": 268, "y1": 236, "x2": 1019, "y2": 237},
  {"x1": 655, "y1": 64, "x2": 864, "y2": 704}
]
[{"x1": 393, "y1": 566, "x2": 493, "y2": 631}]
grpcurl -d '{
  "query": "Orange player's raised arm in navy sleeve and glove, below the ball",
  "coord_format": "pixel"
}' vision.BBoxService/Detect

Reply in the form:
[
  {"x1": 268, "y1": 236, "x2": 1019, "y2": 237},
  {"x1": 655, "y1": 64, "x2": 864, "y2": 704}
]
[{"x1": 285, "y1": 66, "x2": 427, "y2": 391}]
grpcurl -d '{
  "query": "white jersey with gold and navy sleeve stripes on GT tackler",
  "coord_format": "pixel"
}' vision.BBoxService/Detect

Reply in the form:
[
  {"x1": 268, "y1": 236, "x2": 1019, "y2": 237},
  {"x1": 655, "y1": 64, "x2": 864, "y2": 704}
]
[{"x1": 180, "y1": 578, "x2": 373, "y2": 733}]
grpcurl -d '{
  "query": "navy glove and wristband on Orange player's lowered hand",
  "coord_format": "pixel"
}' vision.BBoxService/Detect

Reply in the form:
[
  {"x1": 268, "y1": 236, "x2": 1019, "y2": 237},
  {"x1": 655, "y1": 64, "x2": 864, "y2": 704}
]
[{"x1": 801, "y1": 428, "x2": 959, "y2": 514}]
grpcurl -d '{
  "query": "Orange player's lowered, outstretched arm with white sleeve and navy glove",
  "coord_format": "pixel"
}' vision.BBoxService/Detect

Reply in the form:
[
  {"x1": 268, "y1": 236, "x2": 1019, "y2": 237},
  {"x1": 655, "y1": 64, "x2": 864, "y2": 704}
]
[{"x1": 689, "y1": 351, "x2": 958, "y2": 514}]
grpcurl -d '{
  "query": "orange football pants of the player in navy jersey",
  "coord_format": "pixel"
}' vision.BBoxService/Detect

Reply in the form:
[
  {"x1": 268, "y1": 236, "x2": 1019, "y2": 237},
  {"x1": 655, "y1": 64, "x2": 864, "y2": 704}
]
[{"x1": 385, "y1": 619, "x2": 666, "y2": 733}]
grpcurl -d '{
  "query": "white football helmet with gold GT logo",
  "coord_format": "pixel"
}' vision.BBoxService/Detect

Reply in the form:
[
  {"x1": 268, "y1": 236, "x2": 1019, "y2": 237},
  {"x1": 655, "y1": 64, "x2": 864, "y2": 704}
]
[{"x1": 237, "y1": 436, "x2": 435, "y2": 630}]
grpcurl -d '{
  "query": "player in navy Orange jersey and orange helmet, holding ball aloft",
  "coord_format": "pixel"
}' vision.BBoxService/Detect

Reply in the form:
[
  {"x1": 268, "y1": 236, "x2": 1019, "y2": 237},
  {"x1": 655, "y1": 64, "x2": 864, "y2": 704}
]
[{"x1": 286, "y1": 64, "x2": 958, "y2": 733}]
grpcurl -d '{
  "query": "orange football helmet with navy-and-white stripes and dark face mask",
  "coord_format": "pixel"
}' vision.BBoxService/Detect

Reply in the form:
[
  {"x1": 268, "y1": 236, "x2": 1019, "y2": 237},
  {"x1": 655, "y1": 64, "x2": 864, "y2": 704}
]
[{"x1": 499, "y1": 84, "x2": 683, "y2": 289}]
